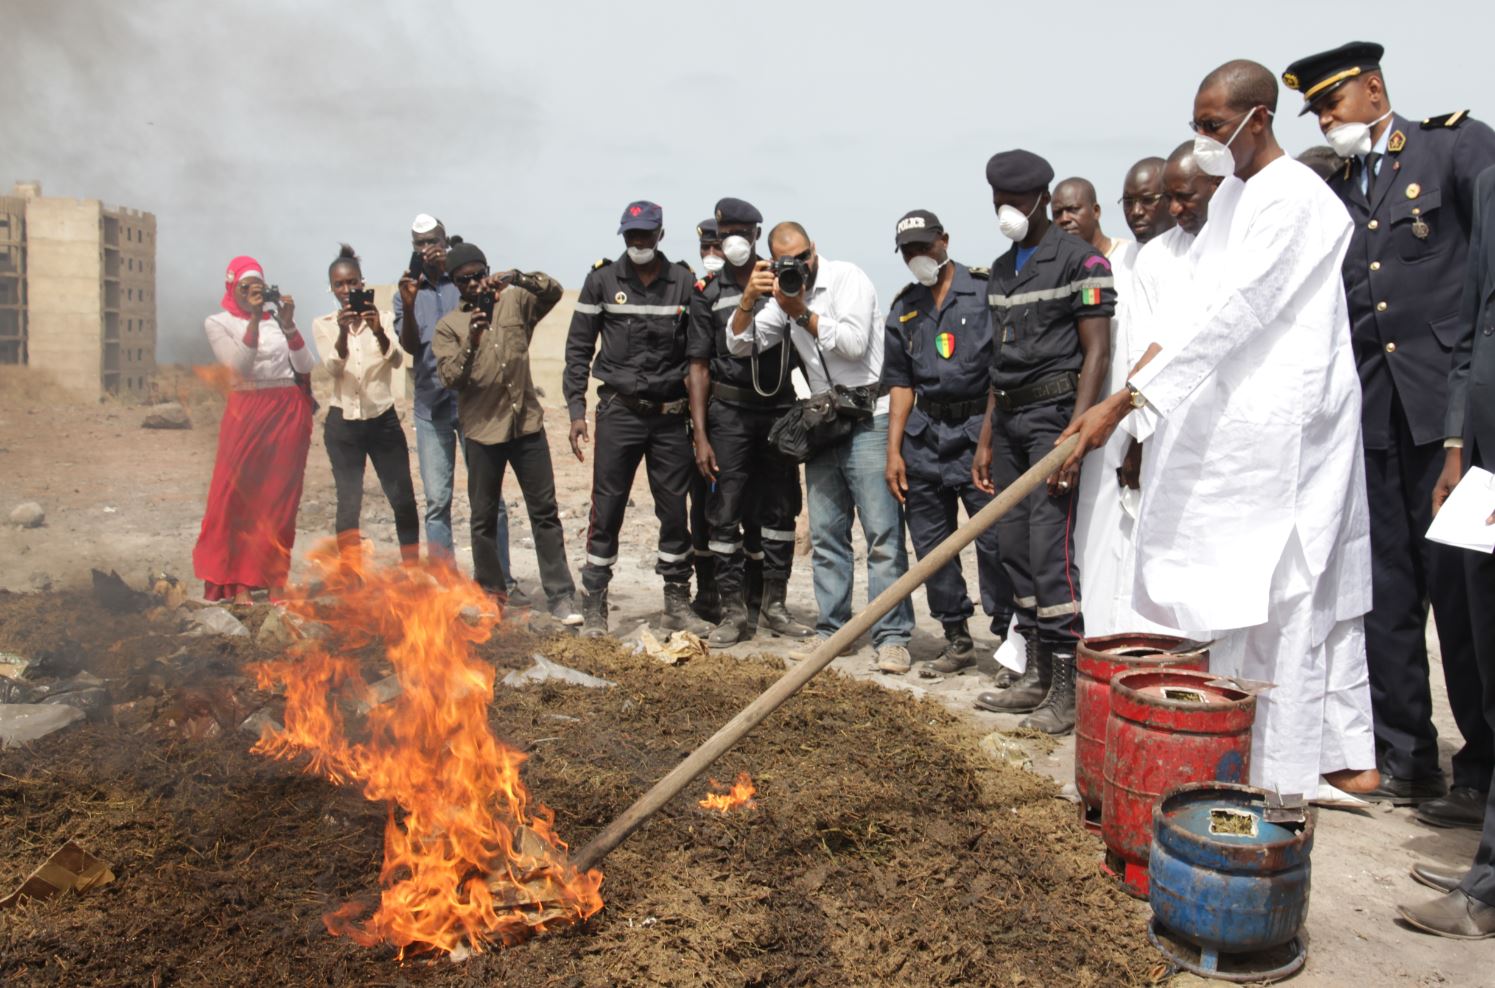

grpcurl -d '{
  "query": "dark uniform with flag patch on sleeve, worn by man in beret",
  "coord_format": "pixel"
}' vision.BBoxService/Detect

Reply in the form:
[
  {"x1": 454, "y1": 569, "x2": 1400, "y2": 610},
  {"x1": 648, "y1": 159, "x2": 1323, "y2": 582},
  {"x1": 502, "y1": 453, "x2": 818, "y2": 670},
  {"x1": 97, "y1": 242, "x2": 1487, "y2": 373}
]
[{"x1": 987, "y1": 226, "x2": 1117, "y2": 653}]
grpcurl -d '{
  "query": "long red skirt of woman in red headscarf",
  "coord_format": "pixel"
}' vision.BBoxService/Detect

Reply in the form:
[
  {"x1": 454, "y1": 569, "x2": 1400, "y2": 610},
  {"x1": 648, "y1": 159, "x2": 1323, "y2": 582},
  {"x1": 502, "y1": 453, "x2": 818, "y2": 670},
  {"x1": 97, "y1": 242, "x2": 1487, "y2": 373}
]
[{"x1": 191, "y1": 384, "x2": 311, "y2": 601}]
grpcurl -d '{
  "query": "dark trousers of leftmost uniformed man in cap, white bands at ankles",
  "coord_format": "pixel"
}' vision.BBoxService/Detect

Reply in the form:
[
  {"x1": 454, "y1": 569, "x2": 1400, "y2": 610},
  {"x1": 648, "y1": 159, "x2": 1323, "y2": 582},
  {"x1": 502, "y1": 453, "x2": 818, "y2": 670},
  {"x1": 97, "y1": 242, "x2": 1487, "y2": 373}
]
[{"x1": 582, "y1": 396, "x2": 697, "y2": 593}]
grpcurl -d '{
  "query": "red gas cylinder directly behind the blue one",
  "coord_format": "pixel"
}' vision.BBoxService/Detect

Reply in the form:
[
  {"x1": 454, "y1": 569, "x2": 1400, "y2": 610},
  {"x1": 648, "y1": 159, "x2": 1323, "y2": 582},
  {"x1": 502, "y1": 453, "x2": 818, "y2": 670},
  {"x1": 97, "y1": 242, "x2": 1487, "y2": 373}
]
[{"x1": 1100, "y1": 670, "x2": 1256, "y2": 898}]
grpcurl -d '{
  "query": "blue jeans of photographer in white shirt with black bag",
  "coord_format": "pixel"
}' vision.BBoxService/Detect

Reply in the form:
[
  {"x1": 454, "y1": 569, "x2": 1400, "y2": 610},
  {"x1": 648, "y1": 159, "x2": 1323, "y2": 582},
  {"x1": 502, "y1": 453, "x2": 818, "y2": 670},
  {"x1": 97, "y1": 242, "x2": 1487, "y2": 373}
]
[{"x1": 804, "y1": 416, "x2": 913, "y2": 647}]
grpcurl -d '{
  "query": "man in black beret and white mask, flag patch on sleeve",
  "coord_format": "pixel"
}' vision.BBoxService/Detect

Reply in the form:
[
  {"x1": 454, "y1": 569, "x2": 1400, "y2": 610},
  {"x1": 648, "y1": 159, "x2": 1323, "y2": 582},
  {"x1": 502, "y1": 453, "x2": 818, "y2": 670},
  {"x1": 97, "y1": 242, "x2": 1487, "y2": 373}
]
[{"x1": 972, "y1": 149, "x2": 1117, "y2": 734}]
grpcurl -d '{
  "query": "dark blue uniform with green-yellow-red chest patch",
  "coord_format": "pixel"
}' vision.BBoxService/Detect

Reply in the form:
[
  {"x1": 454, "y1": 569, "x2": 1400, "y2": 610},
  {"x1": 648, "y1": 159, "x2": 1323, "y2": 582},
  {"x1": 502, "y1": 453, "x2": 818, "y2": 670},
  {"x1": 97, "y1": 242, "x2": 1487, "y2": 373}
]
[{"x1": 882, "y1": 260, "x2": 1012, "y2": 635}]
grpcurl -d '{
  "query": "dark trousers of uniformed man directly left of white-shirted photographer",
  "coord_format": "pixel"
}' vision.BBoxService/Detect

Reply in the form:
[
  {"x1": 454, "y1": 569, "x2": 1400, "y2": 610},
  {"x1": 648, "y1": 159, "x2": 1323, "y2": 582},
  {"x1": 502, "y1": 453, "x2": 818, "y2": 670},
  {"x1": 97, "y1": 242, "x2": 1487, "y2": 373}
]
[{"x1": 706, "y1": 401, "x2": 803, "y2": 599}]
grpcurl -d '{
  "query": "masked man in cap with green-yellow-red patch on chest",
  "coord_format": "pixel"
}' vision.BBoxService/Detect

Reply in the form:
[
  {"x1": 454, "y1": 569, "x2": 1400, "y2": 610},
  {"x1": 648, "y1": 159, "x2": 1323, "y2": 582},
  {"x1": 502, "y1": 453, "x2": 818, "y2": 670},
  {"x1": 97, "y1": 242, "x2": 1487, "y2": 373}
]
[{"x1": 882, "y1": 209, "x2": 1012, "y2": 674}]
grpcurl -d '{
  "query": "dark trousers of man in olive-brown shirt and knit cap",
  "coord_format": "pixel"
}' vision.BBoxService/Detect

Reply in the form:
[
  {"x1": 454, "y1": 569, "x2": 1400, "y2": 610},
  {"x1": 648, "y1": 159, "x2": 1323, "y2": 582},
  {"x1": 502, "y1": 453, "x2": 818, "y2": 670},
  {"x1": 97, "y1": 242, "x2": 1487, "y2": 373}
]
[{"x1": 466, "y1": 429, "x2": 576, "y2": 602}]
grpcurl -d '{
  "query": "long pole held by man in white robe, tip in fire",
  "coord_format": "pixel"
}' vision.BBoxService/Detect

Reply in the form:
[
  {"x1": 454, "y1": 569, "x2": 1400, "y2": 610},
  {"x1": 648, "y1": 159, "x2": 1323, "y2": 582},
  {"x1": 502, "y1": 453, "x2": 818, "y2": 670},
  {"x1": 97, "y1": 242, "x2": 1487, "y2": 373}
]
[{"x1": 571, "y1": 436, "x2": 1079, "y2": 871}]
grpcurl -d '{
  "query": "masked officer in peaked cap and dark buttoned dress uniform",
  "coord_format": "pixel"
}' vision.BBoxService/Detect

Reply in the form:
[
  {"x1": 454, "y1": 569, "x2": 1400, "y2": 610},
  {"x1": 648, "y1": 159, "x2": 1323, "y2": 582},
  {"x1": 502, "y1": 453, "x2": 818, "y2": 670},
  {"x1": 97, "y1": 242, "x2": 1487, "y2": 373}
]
[{"x1": 1283, "y1": 42, "x2": 1495, "y2": 830}]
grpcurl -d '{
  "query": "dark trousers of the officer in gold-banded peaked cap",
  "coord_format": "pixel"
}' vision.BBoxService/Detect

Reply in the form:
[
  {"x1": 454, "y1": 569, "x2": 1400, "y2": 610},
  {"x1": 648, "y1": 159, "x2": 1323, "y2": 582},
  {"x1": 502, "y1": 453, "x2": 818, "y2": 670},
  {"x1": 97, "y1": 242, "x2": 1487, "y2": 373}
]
[{"x1": 1365, "y1": 407, "x2": 1495, "y2": 789}]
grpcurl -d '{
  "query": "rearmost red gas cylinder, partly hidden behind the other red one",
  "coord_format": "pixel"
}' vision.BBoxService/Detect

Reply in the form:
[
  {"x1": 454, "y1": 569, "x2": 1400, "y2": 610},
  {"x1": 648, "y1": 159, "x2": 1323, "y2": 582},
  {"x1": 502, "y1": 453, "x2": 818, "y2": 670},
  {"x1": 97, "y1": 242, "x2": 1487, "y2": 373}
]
[{"x1": 1075, "y1": 632, "x2": 1209, "y2": 831}]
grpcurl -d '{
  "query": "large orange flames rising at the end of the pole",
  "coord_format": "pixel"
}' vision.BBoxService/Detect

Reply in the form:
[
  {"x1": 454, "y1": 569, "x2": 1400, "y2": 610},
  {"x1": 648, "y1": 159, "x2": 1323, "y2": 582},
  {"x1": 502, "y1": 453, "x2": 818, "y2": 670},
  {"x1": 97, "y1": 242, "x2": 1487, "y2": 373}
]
[{"x1": 253, "y1": 547, "x2": 602, "y2": 958}]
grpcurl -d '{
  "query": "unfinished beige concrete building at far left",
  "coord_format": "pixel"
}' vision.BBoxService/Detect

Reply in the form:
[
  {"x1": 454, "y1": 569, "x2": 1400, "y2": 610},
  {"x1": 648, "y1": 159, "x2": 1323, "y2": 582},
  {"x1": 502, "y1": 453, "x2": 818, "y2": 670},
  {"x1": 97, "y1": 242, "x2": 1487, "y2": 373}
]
[{"x1": 0, "y1": 182, "x2": 155, "y2": 396}]
